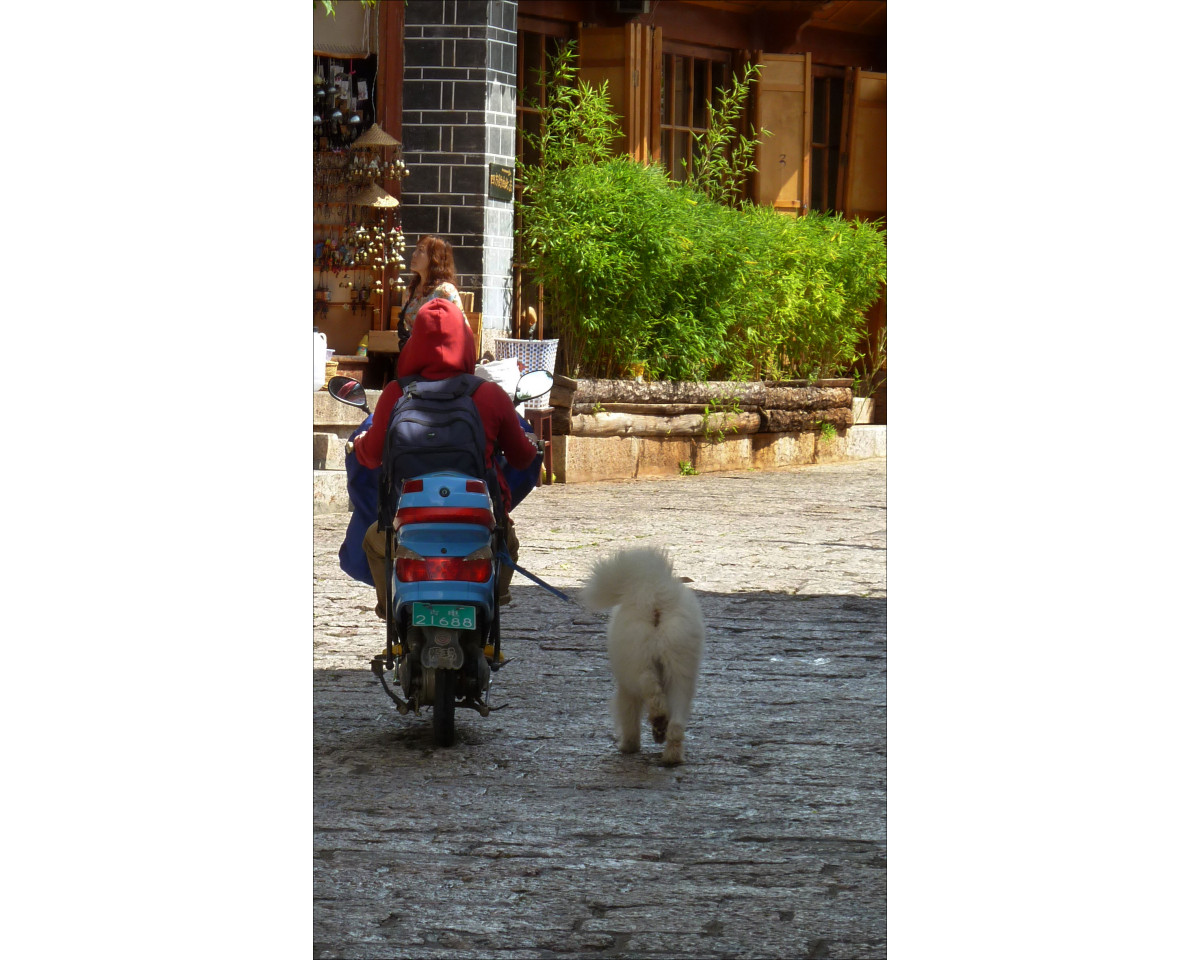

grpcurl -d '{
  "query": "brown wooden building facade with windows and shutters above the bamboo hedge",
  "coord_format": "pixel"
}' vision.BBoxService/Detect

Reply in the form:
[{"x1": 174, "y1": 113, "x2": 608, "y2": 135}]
[{"x1": 517, "y1": 0, "x2": 887, "y2": 220}]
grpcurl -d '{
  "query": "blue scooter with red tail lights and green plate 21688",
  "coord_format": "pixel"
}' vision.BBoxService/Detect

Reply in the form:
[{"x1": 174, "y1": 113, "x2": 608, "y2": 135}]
[{"x1": 329, "y1": 371, "x2": 554, "y2": 746}]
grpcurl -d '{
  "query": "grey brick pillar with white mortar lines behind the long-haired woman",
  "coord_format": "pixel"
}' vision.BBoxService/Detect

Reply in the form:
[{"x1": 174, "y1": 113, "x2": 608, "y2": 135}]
[{"x1": 402, "y1": 0, "x2": 517, "y2": 336}]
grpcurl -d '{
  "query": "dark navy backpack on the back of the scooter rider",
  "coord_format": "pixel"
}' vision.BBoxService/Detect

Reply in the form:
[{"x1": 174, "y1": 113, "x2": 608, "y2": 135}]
[{"x1": 379, "y1": 373, "x2": 493, "y2": 526}]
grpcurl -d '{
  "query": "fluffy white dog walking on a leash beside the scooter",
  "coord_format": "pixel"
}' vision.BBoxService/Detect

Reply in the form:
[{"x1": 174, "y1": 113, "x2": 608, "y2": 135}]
[{"x1": 581, "y1": 547, "x2": 704, "y2": 764}]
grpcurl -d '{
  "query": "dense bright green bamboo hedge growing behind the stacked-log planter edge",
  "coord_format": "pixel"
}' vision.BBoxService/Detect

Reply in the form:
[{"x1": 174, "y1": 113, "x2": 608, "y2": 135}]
[{"x1": 518, "y1": 46, "x2": 887, "y2": 380}]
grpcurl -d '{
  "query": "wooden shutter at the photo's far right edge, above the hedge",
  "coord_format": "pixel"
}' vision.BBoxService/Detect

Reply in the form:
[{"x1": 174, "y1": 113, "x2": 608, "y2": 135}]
[{"x1": 841, "y1": 68, "x2": 888, "y2": 220}]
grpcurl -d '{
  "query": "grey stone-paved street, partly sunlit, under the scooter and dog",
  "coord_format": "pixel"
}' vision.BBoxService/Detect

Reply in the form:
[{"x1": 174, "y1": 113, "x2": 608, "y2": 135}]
[{"x1": 313, "y1": 460, "x2": 887, "y2": 960}]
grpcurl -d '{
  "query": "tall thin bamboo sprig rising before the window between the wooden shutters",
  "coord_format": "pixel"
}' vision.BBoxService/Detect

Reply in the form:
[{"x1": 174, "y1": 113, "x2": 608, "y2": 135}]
[{"x1": 686, "y1": 64, "x2": 770, "y2": 204}]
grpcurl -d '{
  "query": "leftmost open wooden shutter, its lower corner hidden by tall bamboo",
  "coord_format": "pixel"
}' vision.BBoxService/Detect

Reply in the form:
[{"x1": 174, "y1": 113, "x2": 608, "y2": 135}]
[{"x1": 580, "y1": 23, "x2": 662, "y2": 163}]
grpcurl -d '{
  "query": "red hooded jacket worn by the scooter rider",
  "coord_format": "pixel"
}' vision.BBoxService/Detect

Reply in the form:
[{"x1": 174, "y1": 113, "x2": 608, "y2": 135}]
[{"x1": 354, "y1": 298, "x2": 538, "y2": 511}]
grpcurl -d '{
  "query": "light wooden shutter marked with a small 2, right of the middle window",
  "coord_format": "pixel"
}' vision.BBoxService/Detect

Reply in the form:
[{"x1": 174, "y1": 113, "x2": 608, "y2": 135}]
[{"x1": 755, "y1": 53, "x2": 812, "y2": 216}]
